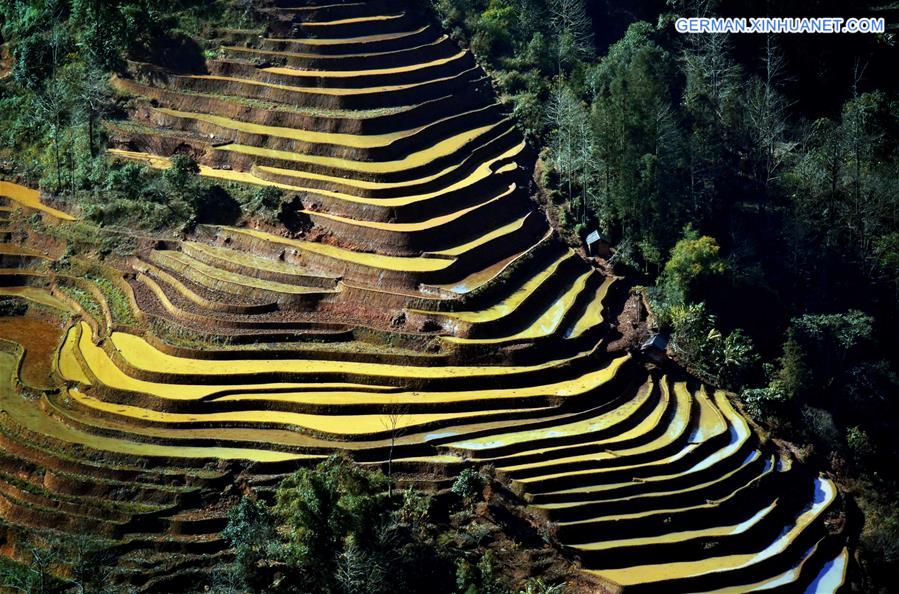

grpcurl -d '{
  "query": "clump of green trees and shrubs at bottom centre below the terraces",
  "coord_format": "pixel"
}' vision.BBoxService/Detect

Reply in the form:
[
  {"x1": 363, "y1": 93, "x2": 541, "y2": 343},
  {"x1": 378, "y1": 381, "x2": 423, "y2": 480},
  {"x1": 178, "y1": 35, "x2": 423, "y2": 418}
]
[{"x1": 220, "y1": 456, "x2": 564, "y2": 594}]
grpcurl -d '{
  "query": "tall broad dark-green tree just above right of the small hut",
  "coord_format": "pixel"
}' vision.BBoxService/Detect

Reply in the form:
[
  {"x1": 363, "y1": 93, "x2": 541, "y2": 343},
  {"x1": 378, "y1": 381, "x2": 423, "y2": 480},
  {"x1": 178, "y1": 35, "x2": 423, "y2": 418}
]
[{"x1": 587, "y1": 22, "x2": 686, "y2": 265}]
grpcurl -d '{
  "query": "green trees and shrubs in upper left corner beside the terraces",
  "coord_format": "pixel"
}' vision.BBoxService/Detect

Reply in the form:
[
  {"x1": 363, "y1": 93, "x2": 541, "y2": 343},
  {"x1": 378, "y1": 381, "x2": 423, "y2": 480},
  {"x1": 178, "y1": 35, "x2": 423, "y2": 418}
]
[{"x1": 0, "y1": 0, "x2": 280, "y2": 236}]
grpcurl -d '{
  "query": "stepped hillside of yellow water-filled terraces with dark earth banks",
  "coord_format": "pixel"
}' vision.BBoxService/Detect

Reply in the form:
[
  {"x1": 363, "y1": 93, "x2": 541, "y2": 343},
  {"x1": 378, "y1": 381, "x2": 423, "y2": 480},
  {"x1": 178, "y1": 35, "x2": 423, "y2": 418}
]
[{"x1": 0, "y1": 0, "x2": 849, "y2": 593}]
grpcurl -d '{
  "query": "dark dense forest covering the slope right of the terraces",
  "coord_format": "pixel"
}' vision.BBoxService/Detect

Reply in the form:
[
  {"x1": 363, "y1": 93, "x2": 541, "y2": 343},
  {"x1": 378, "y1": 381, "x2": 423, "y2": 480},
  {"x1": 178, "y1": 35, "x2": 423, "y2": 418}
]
[{"x1": 434, "y1": 0, "x2": 899, "y2": 579}]
